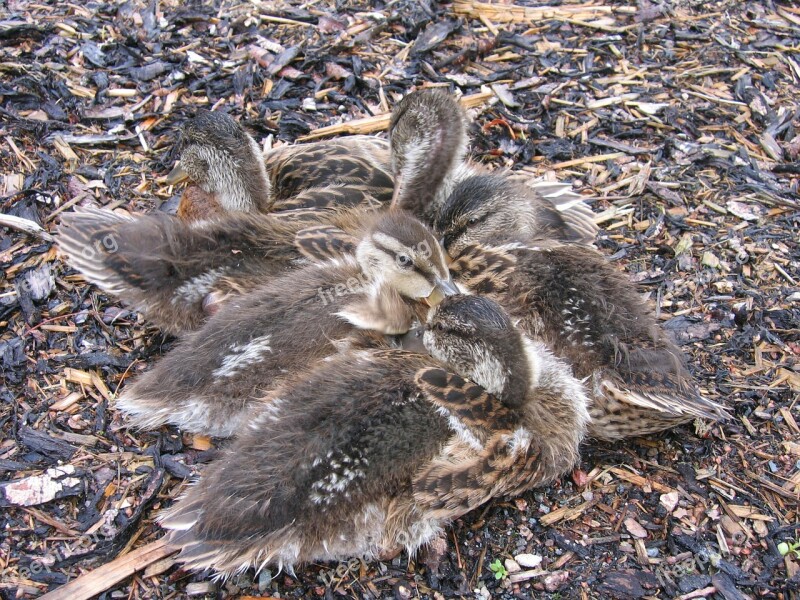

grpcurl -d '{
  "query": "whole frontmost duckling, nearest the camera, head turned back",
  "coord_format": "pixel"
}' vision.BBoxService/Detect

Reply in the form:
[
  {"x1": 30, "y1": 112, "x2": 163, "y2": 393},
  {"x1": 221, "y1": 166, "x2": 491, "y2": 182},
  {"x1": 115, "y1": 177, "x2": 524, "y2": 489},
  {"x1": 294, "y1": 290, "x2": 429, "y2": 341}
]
[{"x1": 159, "y1": 296, "x2": 588, "y2": 577}]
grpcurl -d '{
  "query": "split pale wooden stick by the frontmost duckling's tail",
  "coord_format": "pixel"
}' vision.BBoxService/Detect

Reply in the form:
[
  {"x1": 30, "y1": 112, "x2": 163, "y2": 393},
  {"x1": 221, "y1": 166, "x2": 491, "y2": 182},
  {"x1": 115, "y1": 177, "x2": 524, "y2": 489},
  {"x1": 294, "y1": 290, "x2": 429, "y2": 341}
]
[{"x1": 39, "y1": 539, "x2": 179, "y2": 600}]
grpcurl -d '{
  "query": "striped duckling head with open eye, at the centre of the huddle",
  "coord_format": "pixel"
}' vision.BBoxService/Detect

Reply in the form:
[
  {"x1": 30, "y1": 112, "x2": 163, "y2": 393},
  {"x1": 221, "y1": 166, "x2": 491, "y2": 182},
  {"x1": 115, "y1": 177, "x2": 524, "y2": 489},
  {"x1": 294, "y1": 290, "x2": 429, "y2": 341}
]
[{"x1": 356, "y1": 210, "x2": 458, "y2": 305}]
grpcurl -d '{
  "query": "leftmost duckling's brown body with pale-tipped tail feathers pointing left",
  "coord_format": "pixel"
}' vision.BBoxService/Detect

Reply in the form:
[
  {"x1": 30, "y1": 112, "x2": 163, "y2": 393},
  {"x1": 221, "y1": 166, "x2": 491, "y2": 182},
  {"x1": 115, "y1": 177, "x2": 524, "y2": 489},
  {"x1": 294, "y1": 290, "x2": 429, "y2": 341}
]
[{"x1": 58, "y1": 208, "x2": 422, "y2": 334}]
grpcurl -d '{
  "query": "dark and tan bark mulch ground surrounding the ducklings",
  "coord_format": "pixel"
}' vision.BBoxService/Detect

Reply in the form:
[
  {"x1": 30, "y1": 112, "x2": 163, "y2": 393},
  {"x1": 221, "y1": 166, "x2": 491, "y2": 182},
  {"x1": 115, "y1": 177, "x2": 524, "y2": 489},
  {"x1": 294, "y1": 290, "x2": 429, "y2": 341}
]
[{"x1": 0, "y1": 0, "x2": 800, "y2": 600}]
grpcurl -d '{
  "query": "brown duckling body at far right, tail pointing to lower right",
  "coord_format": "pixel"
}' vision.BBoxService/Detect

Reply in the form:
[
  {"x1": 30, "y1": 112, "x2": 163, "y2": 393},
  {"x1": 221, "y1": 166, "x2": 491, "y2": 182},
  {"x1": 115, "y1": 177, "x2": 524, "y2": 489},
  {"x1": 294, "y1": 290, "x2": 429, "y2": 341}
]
[{"x1": 444, "y1": 239, "x2": 728, "y2": 440}]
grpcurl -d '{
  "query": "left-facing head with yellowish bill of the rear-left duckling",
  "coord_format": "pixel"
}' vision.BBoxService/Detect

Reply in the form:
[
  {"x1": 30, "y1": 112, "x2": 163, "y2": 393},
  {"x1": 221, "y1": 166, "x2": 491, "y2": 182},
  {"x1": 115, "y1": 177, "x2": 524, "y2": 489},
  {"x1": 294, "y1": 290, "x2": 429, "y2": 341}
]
[{"x1": 167, "y1": 111, "x2": 270, "y2": 212}]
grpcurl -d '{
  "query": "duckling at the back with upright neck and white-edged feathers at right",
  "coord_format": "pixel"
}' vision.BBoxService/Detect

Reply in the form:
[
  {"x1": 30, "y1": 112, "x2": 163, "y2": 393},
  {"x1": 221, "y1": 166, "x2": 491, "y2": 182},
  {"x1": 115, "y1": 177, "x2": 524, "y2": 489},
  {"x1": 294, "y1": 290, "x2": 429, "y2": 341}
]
[{"x1": 389, "y1": 89, "x2": 597, "y2": 244}]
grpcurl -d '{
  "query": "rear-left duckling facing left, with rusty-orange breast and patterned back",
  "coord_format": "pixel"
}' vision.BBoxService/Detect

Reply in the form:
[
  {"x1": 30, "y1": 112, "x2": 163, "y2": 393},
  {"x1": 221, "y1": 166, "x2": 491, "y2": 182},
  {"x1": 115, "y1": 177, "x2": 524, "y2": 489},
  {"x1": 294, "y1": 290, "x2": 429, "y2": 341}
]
[{"x1": 166, "y1": 111, "x2": 393, "y2": 220}]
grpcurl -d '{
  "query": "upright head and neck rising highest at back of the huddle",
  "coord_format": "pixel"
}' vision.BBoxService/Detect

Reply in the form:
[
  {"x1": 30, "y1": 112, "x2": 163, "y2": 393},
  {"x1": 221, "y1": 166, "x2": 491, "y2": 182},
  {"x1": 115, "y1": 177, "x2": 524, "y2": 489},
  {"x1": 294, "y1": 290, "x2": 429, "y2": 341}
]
[{"x1": 389, "y1": 89, "x2": 467, "y2": 218}]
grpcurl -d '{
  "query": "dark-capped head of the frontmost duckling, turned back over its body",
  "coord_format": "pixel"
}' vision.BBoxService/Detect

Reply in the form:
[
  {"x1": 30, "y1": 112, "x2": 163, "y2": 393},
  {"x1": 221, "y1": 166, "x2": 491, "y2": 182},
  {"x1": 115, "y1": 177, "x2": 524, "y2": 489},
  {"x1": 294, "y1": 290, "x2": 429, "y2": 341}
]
[{"x1": 422, "y1": 295, "x2": 529, "y2": 406}]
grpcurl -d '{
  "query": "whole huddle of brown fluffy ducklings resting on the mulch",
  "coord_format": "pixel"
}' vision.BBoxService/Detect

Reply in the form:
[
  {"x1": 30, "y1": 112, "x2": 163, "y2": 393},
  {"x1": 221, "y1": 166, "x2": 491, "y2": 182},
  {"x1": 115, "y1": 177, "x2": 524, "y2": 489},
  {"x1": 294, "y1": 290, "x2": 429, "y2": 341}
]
[{"x1": 59, "y1": 89, "x2": 726, "y2": 575}]
